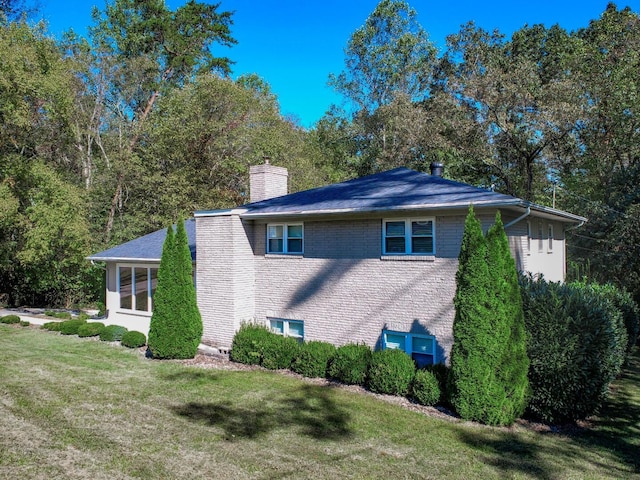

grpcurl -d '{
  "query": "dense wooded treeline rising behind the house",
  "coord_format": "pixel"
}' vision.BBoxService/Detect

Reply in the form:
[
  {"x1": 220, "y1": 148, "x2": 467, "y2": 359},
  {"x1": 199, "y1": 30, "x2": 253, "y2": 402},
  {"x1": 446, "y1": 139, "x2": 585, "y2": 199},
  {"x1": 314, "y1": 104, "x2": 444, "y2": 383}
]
[{"x1": 0, "y1": 0, "x2": 640, "y2": 305}]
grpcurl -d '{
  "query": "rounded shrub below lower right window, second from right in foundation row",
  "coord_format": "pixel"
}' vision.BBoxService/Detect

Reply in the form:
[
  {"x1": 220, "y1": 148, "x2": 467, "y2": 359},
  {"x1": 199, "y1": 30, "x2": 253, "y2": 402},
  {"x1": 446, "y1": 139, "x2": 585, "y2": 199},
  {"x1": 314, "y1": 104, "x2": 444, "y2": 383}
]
[{"x1": 367, "y1": 350, "x2": 416, "y2": 396}]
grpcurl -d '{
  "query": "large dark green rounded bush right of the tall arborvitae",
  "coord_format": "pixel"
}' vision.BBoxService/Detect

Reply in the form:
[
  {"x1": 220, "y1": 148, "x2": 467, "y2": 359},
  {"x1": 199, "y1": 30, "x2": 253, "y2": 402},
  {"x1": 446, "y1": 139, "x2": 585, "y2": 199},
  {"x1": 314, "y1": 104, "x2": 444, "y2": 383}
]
[{"x1": 521, "y1": 277, "x2": 627, "y2": 423}]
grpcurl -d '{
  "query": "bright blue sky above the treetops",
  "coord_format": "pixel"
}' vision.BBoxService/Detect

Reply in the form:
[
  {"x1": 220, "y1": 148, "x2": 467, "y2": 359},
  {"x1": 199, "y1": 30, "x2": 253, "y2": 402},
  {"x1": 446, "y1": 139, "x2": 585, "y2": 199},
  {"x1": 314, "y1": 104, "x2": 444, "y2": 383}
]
[{"x1": 40, "y1": 0, "x2": 640, "y2": 127}]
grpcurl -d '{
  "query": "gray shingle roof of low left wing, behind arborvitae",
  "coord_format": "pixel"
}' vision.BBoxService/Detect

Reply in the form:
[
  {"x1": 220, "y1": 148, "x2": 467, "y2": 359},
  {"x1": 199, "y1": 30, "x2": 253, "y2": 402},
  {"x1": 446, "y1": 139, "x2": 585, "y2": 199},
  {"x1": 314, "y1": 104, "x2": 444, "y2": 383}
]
[{"x1": 87, "y1": 218, "x2": 196, "y2": 262}]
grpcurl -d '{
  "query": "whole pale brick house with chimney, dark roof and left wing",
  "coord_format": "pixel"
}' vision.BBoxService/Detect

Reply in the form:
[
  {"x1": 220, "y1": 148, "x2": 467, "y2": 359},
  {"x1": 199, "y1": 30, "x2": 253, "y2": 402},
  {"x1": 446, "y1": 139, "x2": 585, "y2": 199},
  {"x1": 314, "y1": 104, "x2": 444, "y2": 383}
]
[{"x1": 89, "y1": 164, "x2": 585, "y2": 364}]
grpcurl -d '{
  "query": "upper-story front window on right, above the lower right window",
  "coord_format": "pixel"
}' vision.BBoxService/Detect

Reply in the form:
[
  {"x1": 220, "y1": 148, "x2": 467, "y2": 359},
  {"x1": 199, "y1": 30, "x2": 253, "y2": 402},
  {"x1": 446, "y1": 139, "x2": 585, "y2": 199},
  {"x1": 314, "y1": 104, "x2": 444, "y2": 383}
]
[{"x1": 382, "y1": 218, "x2": 435, "y2": 255}]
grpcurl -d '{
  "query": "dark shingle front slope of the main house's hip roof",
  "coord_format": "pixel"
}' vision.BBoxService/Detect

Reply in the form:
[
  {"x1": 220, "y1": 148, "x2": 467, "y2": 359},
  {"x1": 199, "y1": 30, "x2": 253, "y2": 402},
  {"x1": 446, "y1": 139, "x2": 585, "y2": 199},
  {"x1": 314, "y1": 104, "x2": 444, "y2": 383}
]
[{"x1": 242, "y1": 167, "x2": 522, "y2": 217}]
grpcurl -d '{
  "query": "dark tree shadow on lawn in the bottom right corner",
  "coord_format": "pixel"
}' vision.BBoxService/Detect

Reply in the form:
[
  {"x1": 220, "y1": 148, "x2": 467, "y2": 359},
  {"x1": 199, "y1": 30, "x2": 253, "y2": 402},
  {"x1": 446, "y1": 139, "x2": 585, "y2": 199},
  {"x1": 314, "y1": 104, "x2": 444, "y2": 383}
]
[{"x1": 459, "y1": 352, "x2": 640, "y2": 480}]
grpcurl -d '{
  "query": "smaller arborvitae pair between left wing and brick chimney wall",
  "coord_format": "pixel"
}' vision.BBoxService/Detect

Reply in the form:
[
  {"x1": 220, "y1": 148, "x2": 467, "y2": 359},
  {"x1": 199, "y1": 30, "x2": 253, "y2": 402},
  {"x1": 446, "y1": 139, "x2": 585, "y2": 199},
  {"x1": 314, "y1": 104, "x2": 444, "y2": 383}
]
[{"x1": 148, "y1": 220, "x2": 202, "y2": 359}]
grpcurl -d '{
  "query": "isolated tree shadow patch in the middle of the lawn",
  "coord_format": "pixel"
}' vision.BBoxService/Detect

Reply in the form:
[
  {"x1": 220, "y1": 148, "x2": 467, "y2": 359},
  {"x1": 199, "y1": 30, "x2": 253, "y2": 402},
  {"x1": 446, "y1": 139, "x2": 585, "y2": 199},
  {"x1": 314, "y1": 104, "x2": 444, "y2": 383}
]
[{"x1": 172, "y1": 385, "x2": 352, "y2": 440}]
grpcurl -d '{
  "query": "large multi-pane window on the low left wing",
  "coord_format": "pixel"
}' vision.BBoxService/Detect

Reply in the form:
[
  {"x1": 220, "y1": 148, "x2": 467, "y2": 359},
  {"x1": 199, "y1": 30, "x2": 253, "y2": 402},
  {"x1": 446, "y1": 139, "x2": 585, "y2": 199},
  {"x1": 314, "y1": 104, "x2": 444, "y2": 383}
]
[{"x1": 118, "y1": 266, "x2": 158, "y2": 312}]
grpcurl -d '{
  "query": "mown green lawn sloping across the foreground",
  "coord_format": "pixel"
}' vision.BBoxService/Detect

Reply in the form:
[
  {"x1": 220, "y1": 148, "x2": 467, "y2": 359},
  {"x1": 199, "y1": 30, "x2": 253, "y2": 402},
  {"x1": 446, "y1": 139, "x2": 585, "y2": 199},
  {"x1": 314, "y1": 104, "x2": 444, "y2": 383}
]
[{"x1": 0, "y1": 325, "x2": 640, "y2": 479}]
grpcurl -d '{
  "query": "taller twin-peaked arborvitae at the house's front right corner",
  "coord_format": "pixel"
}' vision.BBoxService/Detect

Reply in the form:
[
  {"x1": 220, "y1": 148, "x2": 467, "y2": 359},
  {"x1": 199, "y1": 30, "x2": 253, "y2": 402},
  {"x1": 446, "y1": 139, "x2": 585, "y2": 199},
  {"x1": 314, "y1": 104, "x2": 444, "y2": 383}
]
[{"x1": 451, "y1": 207, "x2": 529, "y2": 425}]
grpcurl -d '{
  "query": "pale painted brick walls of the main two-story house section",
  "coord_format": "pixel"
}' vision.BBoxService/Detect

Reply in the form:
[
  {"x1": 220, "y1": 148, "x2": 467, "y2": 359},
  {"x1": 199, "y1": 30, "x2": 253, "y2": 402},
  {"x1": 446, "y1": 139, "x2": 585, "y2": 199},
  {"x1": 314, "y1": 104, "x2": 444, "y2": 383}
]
[{"x1": 196, "y1": 208, "x2": 564, "y2": 361}]
